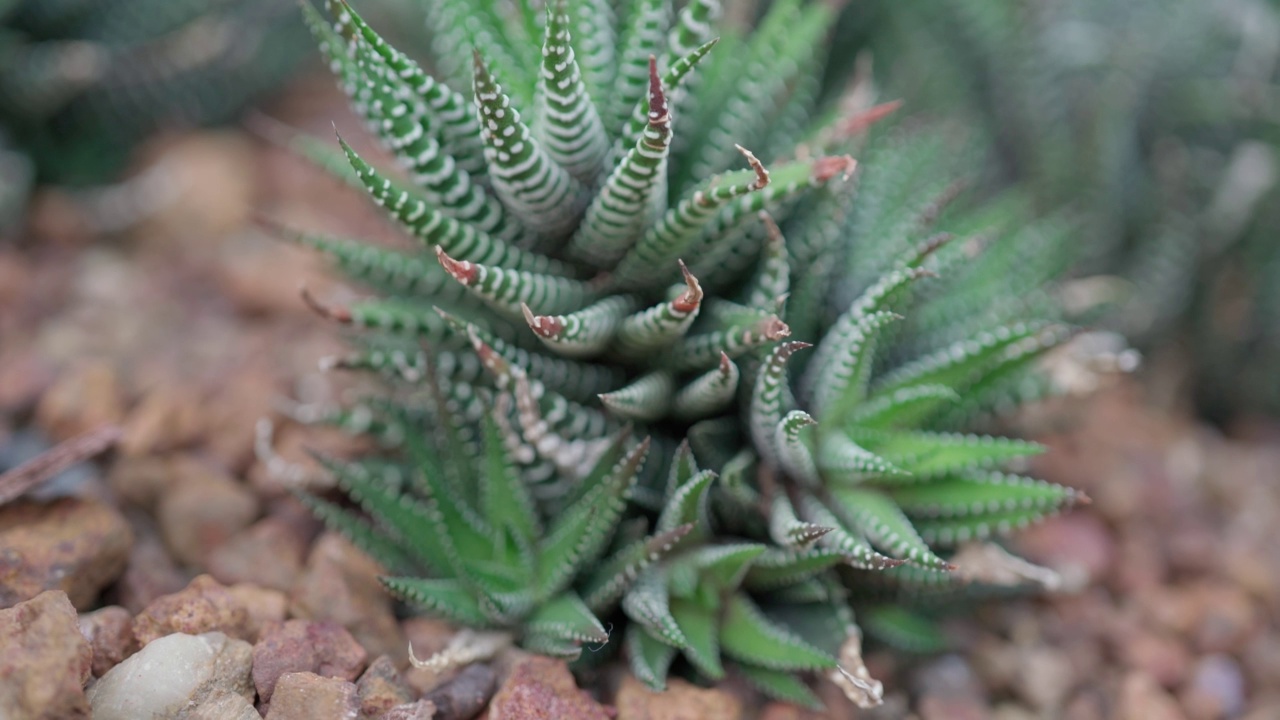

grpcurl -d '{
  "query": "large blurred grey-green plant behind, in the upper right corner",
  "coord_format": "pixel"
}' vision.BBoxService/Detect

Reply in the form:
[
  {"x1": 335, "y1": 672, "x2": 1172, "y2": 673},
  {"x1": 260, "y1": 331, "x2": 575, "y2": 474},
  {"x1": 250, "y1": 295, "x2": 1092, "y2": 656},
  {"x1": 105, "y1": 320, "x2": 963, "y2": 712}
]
[{"x1": 845, "y1": 0, "x2": 1280, "y2": 420}]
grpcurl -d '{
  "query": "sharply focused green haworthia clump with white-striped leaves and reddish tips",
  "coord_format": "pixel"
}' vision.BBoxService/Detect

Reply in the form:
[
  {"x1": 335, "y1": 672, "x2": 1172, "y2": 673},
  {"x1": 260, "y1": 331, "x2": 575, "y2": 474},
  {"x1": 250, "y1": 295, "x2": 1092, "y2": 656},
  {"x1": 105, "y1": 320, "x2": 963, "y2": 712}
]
[{"x1": 280, "y1": 0, "x2": 1079, "y2": 706}]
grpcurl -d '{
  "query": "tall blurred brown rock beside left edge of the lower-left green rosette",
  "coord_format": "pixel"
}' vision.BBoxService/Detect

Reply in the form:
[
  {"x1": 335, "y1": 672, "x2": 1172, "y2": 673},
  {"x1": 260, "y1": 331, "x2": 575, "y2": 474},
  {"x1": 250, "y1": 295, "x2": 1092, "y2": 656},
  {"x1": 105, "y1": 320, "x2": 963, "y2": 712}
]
[{"x1": 289, "y1": 533, "x2": 407, "y2": 657}]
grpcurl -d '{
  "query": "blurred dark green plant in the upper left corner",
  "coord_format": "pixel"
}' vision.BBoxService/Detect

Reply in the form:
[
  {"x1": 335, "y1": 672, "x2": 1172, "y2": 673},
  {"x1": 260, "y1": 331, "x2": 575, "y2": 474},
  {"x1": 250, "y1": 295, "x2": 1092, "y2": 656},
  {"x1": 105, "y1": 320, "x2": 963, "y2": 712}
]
[{"x1": 0, "y1": 0, "x2": 308, "y2": 184}]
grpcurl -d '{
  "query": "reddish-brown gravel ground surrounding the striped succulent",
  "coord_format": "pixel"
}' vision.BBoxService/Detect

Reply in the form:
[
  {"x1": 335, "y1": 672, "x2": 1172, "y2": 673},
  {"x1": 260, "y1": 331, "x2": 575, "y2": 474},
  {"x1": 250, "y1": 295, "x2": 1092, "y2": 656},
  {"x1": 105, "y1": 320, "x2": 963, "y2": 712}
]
[{"x1": 0, "y1": 77, "x2": 1280, "y2": 720}]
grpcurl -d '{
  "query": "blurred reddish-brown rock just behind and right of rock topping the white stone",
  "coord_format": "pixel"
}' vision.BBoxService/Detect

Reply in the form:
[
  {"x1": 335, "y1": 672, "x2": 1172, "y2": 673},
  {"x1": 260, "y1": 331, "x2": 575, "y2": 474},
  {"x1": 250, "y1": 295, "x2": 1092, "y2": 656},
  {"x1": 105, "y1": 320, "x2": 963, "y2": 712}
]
[{"x1": 209, "y1": 516, "x2": 307, "y2": 592}]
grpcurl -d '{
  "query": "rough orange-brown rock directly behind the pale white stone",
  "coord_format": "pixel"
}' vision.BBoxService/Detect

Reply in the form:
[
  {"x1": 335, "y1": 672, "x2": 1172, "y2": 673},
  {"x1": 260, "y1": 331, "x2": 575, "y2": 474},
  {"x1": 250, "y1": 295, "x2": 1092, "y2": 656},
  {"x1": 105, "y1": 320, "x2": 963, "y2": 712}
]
[{"x1": 133, "y1": 575, "x2": 252, "y2": 647}]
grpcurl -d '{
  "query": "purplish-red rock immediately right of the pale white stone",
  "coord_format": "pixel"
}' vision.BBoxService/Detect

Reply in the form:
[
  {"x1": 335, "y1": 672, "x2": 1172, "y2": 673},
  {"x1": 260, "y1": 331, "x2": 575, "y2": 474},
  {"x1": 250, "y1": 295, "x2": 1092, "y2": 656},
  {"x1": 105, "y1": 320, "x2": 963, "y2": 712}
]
[{"x1": 253, "y1": 620, "x2": 367, "y2": 702}]
